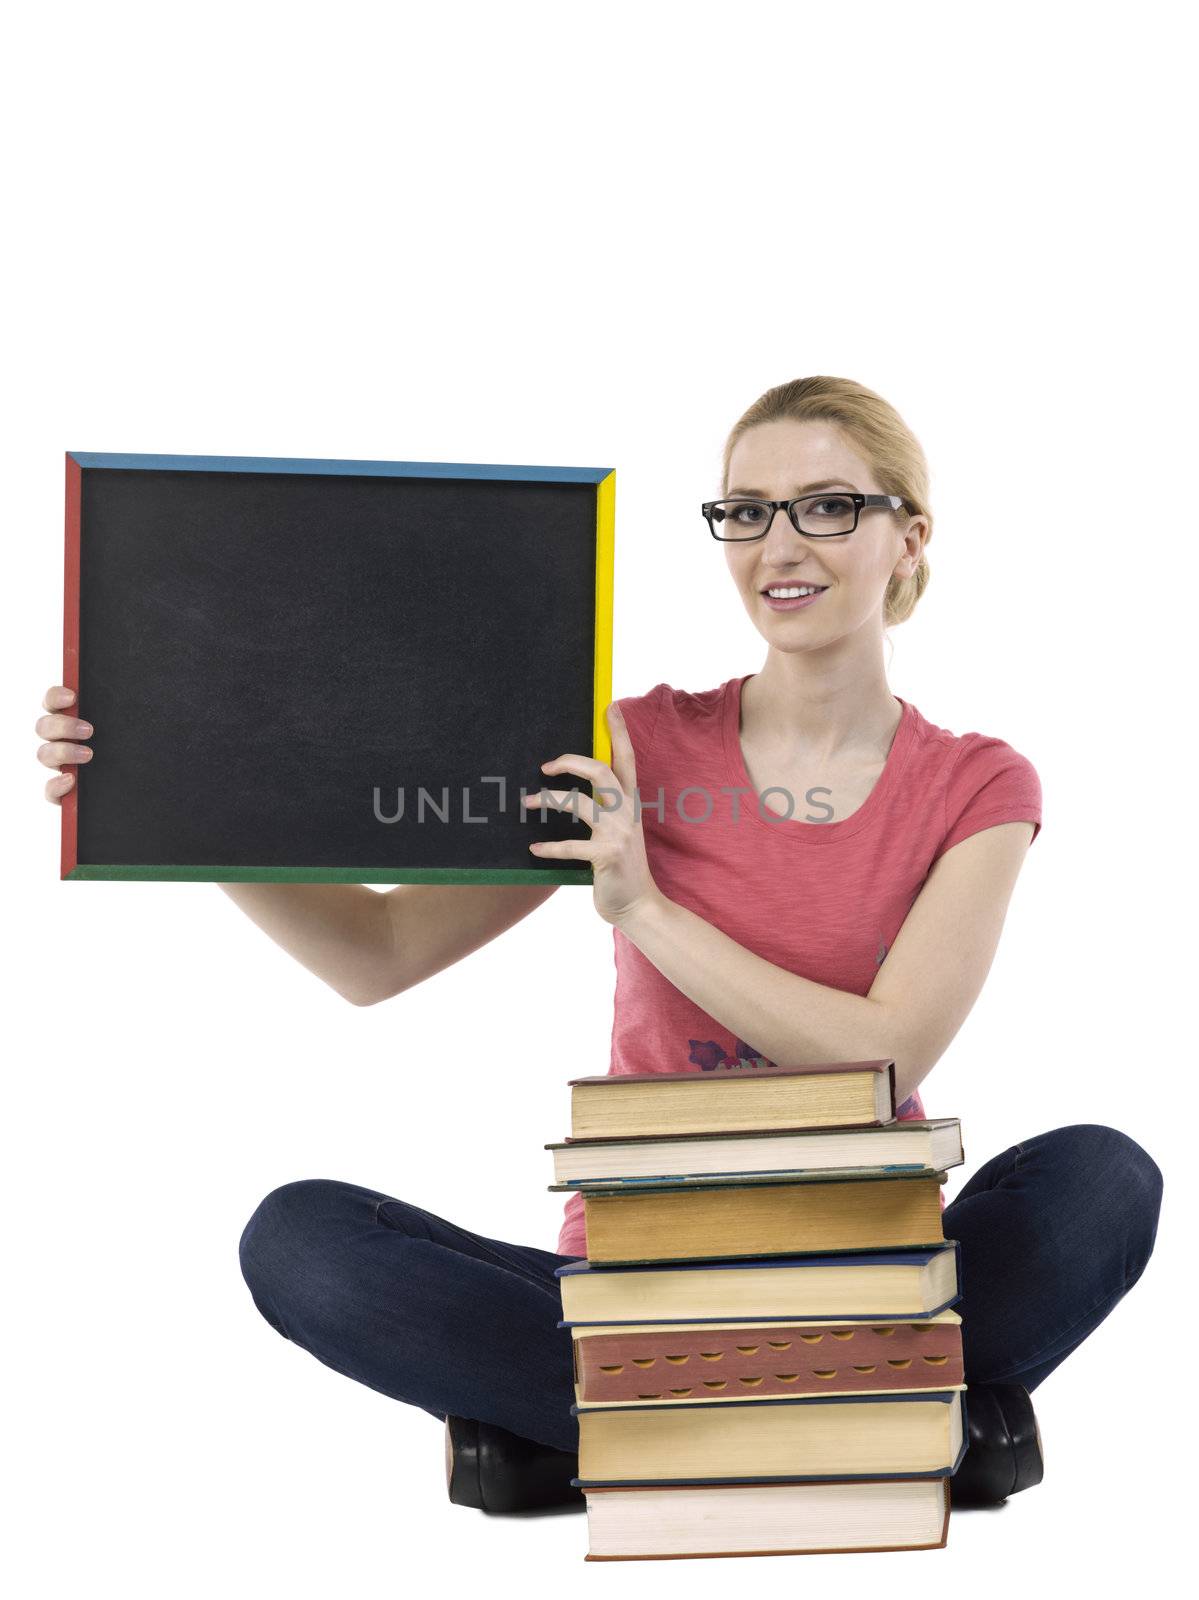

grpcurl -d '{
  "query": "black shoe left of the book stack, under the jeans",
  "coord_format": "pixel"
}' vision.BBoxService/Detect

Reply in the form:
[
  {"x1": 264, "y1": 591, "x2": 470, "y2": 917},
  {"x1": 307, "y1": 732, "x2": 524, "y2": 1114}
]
[{"x1": 445, "y1": 1416, "x2": 586, "y2": 1514}]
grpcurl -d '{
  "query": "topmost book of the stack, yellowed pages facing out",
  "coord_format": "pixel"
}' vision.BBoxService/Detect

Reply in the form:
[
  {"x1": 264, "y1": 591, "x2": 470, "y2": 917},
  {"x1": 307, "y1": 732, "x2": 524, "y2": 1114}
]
[{"x1": 568, "y1": 1061, "x2": 895, "y2": 1139}]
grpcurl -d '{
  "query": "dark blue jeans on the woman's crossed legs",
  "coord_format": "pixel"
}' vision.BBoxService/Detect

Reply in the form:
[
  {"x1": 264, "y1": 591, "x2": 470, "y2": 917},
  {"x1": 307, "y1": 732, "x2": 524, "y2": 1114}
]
[{"x1": 240, "y1": 1123, "x2": 1162, "y2": 1451}]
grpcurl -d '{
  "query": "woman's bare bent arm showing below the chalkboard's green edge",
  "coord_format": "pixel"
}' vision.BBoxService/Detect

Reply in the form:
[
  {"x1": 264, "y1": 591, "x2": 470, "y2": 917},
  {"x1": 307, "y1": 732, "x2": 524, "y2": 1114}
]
[{"x1": 221, "y1": 883, "x2": 557, "y2": 1005}]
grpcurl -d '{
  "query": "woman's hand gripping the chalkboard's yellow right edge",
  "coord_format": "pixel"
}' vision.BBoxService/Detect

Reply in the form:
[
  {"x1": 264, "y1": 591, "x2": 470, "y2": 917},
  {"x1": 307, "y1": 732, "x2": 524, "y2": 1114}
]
[{"x1": 523, "y1": 701, "x2": 660, "y2": 925}]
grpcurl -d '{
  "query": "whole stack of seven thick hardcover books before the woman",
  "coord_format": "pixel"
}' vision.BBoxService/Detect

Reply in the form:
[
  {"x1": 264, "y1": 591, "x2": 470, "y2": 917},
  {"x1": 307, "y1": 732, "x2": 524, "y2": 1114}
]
[{"x1": 546, "y1": 1061, "x2": 967, "y2": 1560}]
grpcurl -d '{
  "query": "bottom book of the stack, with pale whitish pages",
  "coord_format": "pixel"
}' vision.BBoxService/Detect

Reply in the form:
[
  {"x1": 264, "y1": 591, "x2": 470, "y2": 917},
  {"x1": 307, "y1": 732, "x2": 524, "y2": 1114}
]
[{"x1": 584, "y1": 1477, "x2": 949, "y2": 1562}]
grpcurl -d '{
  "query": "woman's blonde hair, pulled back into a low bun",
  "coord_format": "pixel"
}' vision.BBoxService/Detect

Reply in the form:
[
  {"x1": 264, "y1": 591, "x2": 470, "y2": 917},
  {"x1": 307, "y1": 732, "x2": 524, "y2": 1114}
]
[{"x1": 720, "y1": 378, "x2": 933, "y2": 627}]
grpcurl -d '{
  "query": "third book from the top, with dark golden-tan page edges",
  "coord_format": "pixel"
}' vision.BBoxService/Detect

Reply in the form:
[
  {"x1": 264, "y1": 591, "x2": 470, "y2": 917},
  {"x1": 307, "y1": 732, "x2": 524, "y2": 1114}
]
[{"x1": 583, "y1": 1173, "x2": 946, "y2": 1262}]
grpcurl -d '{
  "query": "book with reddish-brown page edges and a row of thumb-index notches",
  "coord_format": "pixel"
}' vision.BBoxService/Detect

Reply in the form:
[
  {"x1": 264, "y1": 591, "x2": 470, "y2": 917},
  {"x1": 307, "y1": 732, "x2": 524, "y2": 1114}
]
[{"x1": 571, "y1": 1310, "x2": 965, "y2": 1405}]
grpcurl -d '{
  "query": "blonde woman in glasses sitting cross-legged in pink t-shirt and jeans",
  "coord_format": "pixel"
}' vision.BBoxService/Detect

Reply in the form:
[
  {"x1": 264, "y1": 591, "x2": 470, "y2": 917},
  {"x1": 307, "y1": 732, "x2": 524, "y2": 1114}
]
[{"x1": 37, "y1": 378, "x2": 1162, "y2": 1512}]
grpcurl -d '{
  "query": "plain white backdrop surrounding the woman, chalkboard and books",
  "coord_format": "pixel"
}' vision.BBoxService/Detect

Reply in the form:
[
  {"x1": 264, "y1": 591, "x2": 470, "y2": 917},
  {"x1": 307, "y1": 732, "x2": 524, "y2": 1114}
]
[{"x1": 0, "y1": 0, "x2": 1196, "y2": 1600}]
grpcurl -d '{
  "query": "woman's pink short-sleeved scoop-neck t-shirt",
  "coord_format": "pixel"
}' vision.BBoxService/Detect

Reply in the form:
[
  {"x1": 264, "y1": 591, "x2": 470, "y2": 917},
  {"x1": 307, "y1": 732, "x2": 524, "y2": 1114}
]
[{"x1": 557, "y1": 674, "x2": 1041, "y2": 1256}]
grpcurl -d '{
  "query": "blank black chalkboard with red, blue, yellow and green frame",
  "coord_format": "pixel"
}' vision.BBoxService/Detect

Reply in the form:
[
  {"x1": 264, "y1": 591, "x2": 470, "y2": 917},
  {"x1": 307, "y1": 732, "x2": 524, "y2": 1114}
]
[{"x1": 61, "y1": 451, "x2": 615, "y2": 885}]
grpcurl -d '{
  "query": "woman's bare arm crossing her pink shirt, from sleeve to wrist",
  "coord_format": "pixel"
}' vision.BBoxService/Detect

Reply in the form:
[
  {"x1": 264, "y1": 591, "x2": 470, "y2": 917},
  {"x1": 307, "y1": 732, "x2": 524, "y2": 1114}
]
[{"x1": 616, "y1": 822, "x2": 1033, "y2": 1106}]
